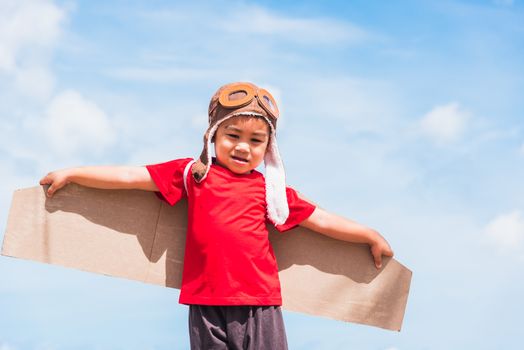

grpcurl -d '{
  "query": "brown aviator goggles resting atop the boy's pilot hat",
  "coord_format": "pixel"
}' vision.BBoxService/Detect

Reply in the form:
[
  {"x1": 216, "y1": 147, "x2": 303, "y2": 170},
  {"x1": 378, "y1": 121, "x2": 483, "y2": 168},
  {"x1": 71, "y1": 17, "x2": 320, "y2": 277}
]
[{"x1": 214, "y1": 83, "x2": 279, "y2": 119}]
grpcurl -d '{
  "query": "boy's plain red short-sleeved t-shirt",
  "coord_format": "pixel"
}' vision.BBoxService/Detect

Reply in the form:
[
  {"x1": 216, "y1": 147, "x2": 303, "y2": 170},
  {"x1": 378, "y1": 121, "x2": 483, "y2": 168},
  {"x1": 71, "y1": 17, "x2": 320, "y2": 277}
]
[{"x1": 146, "y1": 158, "x2": 315, "y2": 305}]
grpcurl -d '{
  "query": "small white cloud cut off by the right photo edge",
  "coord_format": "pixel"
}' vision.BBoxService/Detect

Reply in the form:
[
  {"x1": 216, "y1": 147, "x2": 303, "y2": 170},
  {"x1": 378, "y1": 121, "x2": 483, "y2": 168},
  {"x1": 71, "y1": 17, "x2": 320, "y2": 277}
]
[{"x1": 484, "y1": 210, "x2": 524, "y2": 252}]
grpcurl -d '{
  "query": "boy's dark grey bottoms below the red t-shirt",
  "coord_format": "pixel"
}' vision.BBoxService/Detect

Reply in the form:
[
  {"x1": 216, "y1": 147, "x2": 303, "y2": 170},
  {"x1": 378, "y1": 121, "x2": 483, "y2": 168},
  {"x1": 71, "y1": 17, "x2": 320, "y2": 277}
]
[{"x1": 189, "y1": 305, "x2": 287, "y2": 350}]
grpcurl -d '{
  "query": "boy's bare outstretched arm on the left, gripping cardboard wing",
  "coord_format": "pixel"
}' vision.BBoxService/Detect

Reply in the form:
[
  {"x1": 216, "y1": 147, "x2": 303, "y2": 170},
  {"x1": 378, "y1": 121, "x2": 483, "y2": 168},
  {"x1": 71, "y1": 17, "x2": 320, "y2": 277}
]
[{"x1": 40, "y1": 166, "x2": 158, "y2": 197}]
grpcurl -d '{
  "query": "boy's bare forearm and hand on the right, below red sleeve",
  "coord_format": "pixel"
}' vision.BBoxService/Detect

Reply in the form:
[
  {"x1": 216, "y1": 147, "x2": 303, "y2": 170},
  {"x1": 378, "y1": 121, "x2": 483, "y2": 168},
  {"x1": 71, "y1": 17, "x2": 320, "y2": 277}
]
[{"x1": 300, "y1": 207, "x2": 393, "y2": 269}]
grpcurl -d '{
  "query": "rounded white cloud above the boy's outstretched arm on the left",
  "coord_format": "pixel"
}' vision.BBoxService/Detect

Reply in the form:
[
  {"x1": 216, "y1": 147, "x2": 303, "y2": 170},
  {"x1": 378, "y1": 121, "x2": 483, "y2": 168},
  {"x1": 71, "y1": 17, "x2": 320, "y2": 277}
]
[{"x1": 44, "y1": 90, "x2": 116, "y2": 156}]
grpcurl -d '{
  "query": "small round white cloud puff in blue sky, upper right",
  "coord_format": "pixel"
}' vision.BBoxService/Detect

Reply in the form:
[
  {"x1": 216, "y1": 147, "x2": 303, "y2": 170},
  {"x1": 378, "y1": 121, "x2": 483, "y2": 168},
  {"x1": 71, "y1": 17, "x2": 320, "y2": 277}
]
[{"x1": 420, "y1": 103, "x2": 470, "y2": 144}]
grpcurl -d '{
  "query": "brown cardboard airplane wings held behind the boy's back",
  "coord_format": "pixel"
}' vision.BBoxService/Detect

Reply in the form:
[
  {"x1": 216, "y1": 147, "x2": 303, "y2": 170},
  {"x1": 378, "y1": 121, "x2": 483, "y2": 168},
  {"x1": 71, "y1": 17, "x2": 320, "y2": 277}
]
[{"x1": 2, "y1": 184, "x2": 411, "y2": 330}]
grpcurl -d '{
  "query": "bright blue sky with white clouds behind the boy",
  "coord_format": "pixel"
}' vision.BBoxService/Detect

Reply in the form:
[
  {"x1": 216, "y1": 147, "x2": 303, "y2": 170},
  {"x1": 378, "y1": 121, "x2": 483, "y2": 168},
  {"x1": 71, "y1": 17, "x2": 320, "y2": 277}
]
[{"x1": 0, "y1": 0, "x2": 524, "y2": 350}]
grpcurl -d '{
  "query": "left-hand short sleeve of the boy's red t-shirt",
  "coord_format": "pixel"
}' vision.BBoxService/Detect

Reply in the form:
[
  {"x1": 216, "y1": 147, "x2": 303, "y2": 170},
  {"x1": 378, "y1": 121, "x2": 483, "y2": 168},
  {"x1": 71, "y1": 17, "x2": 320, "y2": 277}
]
[{"x1": 146, "y1": 158, "x2": 192, "y2": 205}]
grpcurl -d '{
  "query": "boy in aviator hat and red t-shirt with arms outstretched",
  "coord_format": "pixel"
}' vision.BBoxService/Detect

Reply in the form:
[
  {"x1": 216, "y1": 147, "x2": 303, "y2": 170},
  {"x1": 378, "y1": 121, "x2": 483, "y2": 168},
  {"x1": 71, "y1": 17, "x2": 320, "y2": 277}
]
[{"x1": 40, "y1": 83, "x2": 393, "y2": 350}]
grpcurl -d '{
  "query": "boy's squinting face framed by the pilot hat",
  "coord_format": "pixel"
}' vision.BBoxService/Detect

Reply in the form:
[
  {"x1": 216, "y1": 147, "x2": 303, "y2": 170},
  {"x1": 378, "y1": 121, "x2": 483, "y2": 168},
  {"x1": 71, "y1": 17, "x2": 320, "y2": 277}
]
[{"x1": 215, "y1": 116, "x2": 269, "y2": 174}]
